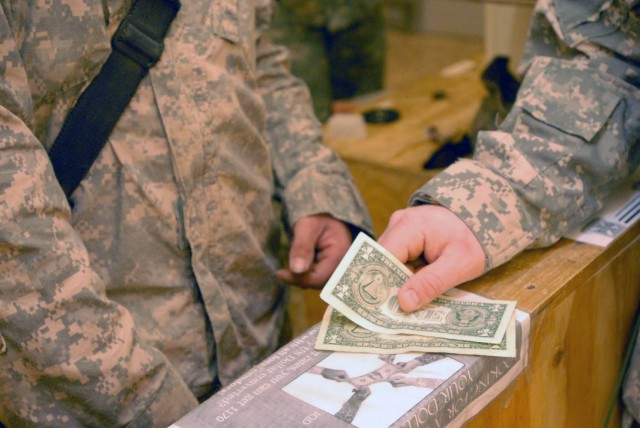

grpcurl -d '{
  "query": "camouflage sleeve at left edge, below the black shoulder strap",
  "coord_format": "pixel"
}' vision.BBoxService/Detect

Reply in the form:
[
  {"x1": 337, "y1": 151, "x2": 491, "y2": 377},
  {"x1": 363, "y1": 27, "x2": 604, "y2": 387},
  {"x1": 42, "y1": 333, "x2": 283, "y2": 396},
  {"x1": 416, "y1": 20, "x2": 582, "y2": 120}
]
[{"x1": 0, "y1": 9, "x2": 197, "y2": 427}]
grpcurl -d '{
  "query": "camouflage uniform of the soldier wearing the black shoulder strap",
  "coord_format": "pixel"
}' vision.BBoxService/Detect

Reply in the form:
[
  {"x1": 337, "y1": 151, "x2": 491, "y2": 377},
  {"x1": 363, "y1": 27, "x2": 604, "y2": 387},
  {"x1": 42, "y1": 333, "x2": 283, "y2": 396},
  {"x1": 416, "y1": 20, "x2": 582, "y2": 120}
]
[{"x1": 0, "y1": 0, "x2": 370, "y2": 427}]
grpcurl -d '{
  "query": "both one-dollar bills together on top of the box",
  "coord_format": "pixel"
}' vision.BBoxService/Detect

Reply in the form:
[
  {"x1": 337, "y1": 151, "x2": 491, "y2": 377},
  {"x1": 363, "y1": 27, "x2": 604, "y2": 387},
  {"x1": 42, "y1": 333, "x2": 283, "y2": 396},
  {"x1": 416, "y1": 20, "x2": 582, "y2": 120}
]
[{"x1": 315, "y1": 233, "x2": 516, "y2": 357}]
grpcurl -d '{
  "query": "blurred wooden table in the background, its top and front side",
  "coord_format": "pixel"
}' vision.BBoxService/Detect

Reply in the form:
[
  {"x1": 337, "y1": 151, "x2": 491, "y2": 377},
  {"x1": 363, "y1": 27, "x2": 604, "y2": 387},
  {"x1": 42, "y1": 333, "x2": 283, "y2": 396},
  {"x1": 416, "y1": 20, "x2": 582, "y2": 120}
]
[{"x1": 325, "y1": 59, "x2": 486, "y2": 234}]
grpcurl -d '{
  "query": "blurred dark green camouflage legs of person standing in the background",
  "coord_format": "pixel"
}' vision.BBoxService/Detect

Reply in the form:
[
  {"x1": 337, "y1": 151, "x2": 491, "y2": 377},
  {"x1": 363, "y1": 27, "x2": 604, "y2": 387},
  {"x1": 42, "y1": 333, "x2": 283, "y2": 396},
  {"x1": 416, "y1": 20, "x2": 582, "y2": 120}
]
[{"x1": 270, "y1": 0, "x2": 385, "y2": 121}]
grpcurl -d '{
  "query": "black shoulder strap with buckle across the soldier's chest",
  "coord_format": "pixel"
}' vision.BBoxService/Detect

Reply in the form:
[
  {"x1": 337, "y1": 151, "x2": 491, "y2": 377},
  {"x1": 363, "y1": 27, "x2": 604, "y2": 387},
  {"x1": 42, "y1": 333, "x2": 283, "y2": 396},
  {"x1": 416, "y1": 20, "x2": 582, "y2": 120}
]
[{"x1": 49, "y1": 0, "x2": 180, "y2": 198}]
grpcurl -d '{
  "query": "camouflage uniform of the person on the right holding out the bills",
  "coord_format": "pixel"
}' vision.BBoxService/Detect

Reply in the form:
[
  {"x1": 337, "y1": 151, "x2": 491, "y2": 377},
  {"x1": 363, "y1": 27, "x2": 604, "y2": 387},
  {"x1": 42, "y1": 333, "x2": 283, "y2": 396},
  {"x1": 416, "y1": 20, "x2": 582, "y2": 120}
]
[{"x1": 412, "y1": 0, "x2": 640, "y2": 418}]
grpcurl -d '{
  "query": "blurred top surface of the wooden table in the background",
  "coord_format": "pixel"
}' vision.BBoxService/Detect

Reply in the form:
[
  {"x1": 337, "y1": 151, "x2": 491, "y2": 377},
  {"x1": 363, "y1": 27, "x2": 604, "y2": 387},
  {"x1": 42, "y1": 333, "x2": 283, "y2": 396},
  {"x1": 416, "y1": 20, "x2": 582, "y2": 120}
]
[{"x1": 325, "y1": 58, "x2": 486, "y2": 173}]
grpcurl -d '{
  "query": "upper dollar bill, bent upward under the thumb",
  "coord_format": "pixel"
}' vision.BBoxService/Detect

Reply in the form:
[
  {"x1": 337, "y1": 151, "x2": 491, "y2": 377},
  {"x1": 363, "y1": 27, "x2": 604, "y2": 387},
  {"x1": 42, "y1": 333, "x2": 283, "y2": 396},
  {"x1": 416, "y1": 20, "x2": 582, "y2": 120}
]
[{"x1": 320, "y1": 233, "x2": 515, "y2": 344}]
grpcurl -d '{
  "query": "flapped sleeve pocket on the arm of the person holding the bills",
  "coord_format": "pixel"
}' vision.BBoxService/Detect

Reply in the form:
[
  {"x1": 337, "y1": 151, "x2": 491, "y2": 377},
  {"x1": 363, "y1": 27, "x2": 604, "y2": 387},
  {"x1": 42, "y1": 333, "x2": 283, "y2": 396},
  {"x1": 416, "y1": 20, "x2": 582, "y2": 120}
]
[{"x1": 505, "y1": 58, "x2": 620, "y2": 183}]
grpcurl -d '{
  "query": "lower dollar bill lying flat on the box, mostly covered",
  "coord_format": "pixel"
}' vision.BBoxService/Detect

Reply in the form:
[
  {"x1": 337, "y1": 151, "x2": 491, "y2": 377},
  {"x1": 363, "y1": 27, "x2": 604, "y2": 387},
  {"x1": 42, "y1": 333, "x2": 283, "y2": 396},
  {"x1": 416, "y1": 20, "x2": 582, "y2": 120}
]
[{"x1": 315, "y1": 306, "x2": 516, "y2": 357}]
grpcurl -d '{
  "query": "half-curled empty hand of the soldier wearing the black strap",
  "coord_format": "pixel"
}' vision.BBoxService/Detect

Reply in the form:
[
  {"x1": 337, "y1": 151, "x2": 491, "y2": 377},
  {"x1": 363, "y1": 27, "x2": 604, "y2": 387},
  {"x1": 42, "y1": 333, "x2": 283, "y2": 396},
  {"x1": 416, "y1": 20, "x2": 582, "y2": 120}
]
[{"x1": 276, "y1": 215, "x2": 351, "y2": 288}]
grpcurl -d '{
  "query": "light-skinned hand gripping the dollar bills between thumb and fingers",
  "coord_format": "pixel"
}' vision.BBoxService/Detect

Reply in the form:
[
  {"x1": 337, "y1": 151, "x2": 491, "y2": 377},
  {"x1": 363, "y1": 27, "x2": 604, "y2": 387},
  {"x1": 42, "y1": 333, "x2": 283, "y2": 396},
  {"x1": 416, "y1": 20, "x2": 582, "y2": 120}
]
[{"x1": 378, "y1": 205, "x2": 485, "y2": 311}]
